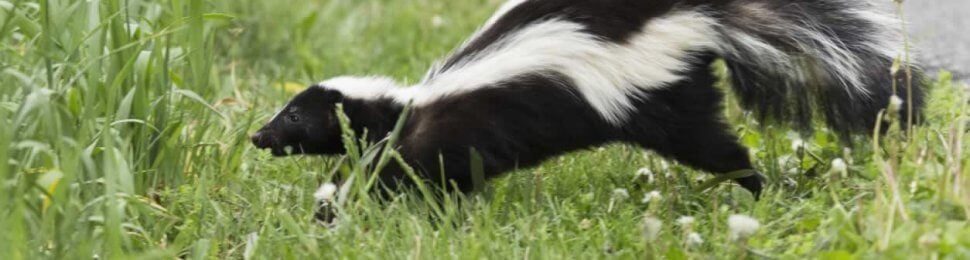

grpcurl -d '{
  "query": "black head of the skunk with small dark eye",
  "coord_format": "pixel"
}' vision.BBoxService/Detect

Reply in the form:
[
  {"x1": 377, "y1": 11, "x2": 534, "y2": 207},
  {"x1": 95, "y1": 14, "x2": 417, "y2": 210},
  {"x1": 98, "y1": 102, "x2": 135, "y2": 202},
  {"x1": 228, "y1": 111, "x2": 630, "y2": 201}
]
[{"x1": 250, "y1": 86, "x2": 344, "y2": 156}]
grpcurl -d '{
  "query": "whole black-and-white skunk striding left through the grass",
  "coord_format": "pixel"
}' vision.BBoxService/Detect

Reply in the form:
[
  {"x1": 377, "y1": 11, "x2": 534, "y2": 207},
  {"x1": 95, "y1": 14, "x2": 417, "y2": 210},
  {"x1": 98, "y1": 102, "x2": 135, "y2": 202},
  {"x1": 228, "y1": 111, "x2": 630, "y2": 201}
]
[{"x1": 252, "y1": 0, "x2": 923, "y2": 200}]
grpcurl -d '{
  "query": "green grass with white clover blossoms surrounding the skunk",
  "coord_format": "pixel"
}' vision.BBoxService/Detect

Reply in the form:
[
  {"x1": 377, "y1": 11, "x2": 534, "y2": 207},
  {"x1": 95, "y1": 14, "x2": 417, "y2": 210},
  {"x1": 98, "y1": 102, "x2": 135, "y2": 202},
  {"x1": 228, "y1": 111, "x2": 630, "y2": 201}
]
[{"x1": 0, "y1": 0, "x2": 970, "y2": 259}]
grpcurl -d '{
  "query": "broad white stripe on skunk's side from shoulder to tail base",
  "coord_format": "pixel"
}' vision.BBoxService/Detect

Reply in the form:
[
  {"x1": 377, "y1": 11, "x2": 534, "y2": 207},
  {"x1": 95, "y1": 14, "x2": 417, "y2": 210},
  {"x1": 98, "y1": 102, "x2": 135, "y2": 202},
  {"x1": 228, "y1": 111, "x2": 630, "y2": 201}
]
[{"x1": 394, "y1": 11, "x2": 716, "y2": 125}]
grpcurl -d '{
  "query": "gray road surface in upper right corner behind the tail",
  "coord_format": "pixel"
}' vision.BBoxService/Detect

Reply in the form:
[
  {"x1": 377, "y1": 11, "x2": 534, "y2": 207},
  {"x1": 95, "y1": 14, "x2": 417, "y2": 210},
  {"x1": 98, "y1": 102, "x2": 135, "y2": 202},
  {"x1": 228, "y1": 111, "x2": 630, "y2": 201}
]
[{"x1": 903, "y1": 0, "x2": 970, "y2": 81}]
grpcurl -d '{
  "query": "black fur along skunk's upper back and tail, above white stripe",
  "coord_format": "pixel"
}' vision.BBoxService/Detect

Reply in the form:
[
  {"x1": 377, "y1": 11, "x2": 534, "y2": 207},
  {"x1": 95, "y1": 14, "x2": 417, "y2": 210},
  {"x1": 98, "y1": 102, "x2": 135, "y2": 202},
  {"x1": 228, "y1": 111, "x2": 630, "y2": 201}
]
[{"x1": 436, "y1": 0, "x2": 924, "y2": 141}]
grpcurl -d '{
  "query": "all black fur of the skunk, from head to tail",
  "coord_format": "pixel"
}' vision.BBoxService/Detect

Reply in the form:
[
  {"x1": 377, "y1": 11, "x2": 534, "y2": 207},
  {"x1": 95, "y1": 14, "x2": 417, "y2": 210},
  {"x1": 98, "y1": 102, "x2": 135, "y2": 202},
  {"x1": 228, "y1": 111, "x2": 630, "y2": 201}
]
[{"x1": 253, "y1": 0, "x2": 923, "y2": 215}]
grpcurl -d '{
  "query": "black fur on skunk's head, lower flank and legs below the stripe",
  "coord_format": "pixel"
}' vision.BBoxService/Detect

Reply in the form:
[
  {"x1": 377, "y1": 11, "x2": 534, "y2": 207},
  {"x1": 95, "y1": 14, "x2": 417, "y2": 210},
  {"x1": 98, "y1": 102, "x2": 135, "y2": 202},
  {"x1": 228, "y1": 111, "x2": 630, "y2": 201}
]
[{"x1": 254, "y1": 54, "x2": 761, "y2": 197}]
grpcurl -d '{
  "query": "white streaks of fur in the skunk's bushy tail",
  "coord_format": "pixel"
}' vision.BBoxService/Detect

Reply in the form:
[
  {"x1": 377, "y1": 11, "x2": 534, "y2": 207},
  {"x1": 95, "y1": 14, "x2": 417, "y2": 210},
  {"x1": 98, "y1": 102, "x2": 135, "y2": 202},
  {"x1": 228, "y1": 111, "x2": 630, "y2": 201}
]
[{"x1": 719, "y1": 2, "x2": 902, "y2": 95}]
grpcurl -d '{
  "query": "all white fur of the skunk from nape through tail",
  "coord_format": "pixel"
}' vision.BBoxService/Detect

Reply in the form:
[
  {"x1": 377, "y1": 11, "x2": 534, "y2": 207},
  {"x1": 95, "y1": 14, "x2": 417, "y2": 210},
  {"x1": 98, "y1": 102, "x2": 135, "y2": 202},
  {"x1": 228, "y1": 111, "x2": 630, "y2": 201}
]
[{"x1": 321, "y1": 4, "x2": 898, "y2": 125}]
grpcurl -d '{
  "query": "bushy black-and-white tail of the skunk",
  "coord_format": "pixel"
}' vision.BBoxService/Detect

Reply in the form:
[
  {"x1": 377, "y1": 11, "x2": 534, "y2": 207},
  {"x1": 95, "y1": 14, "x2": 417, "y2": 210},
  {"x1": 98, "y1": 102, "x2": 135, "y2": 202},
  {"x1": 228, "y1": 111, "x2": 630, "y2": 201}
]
[{"x1": 719, "y1": 0, "x2": 923, "y2": 138}]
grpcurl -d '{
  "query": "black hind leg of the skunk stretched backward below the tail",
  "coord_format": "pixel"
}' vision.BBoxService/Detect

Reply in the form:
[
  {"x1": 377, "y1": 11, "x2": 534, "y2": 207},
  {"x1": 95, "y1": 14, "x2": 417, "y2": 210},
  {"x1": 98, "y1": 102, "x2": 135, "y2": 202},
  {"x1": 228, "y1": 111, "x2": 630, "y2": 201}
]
[{"x1": 622, "y1": 65, "x2": 765, "y2": 198}]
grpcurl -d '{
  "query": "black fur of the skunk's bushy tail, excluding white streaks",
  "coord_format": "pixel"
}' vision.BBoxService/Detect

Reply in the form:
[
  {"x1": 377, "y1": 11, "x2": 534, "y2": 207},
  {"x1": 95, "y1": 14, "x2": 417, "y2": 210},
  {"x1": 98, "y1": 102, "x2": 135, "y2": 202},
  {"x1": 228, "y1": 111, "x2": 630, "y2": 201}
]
[{"x1": 712, "y1": 0, "x2": 924, "y2": 138}]
